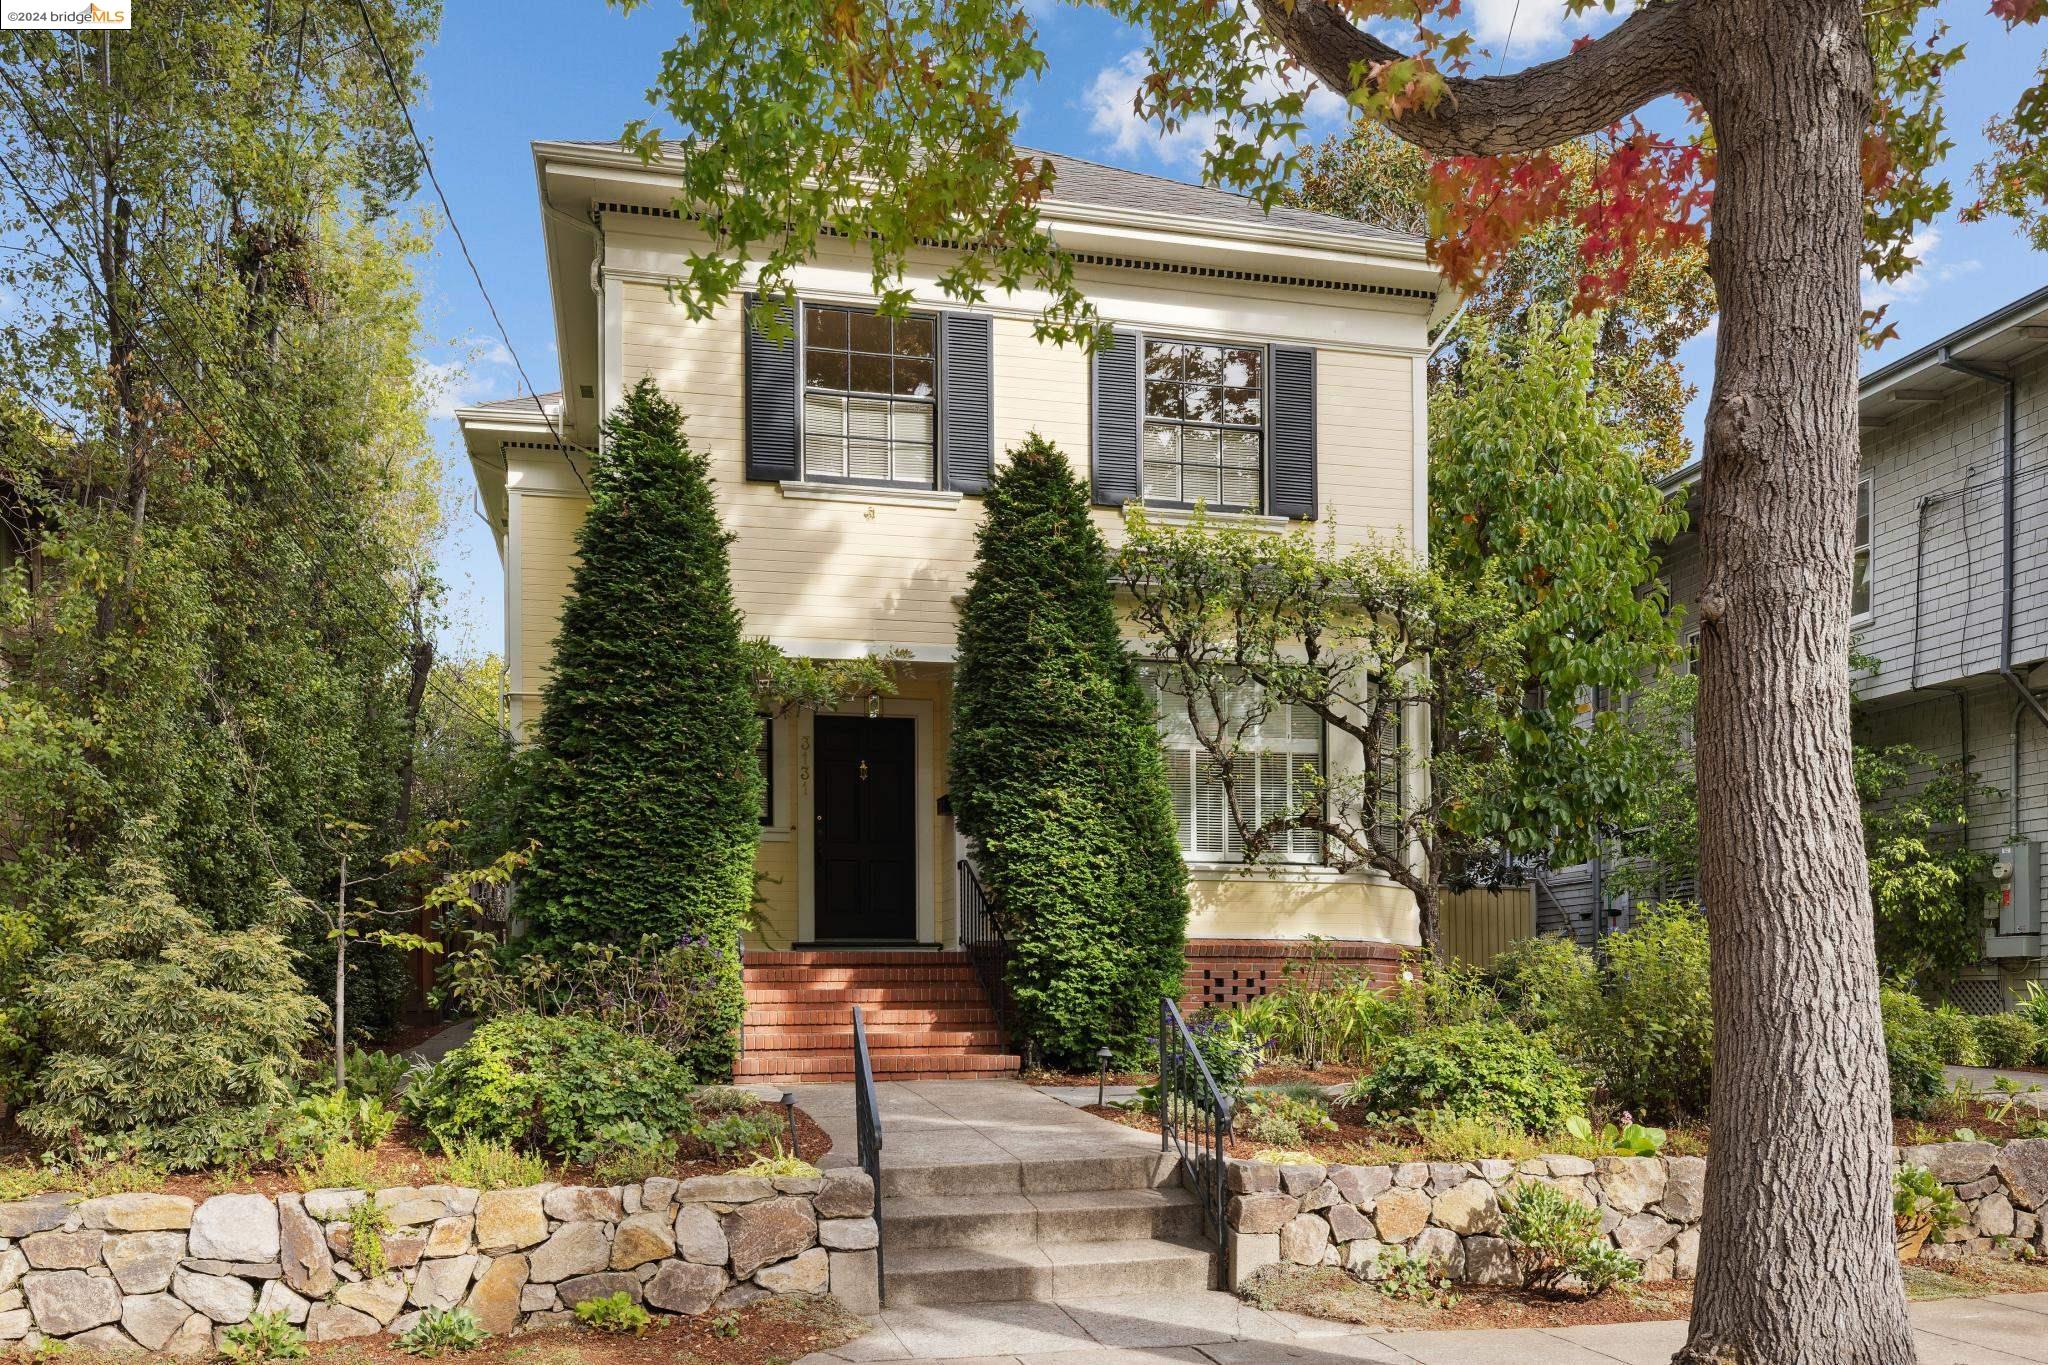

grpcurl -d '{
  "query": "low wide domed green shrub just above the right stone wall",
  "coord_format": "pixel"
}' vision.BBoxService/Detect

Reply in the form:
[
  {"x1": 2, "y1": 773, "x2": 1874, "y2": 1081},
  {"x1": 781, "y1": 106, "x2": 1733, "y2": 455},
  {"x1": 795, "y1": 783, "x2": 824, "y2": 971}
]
[{"x1": 1350, "y1": 1021, "x2": 1585, "y2": 1132}]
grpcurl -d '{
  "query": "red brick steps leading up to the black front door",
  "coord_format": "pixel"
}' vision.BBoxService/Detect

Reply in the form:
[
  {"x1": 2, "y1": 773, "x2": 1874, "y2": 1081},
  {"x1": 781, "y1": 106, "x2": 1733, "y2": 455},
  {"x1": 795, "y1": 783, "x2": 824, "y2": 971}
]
[{"x1": 733, "y1": 950, "x2": 1018, "y2": 1081}]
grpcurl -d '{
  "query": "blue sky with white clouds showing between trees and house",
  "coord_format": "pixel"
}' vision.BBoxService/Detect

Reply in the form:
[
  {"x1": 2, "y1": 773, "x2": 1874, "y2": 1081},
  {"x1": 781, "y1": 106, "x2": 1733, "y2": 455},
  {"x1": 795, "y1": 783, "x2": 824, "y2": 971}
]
[{"x1": 414, "y1": 0, "x2": 2048, "y2": 653}]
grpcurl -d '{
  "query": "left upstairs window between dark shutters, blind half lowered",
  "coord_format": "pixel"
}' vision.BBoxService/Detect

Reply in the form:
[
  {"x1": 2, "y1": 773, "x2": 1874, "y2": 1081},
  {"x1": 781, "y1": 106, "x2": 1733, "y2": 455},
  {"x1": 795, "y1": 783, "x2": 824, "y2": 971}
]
[{"x1": 803, "y1": 303, "x2": 938, "y2": 489}]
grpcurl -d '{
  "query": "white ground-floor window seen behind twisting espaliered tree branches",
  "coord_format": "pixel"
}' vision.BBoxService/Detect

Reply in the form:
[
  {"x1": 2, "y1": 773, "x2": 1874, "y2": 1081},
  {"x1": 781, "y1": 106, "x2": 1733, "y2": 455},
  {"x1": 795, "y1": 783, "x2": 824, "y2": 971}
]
[{"x1": 1145, "y1": 667, "x2": 1323, "y2": 864}]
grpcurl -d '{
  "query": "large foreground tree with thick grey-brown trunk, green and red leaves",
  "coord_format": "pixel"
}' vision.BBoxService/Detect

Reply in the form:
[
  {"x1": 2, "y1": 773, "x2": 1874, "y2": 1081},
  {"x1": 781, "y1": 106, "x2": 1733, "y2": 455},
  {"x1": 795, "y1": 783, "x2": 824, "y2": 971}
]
[{"x1": 618, "y1": 0, "x2": 2048, "y2": 1365}]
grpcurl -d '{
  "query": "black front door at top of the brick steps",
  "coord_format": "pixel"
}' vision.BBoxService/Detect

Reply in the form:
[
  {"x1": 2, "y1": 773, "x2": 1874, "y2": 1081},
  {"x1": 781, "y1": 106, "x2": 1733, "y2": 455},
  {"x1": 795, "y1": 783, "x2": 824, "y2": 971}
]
[{"x1": 813, "y1": 716, "x2": 918, "y2": 943}]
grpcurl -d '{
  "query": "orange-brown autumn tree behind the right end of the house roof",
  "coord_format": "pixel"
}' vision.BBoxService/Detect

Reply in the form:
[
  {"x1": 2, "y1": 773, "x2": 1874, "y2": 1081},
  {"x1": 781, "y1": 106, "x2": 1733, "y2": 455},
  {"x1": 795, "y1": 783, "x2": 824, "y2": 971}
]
[{"x1": 1286, "y1": 121, "x2": 1714, "y2": 473}]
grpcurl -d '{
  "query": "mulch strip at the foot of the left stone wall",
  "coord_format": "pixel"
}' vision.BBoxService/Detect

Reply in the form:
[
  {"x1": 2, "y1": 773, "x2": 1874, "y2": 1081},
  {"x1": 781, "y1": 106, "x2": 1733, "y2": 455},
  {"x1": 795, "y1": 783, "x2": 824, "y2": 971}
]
[{"x1": 292, "y1": 1297, "x2": 868, "y2": 1365}]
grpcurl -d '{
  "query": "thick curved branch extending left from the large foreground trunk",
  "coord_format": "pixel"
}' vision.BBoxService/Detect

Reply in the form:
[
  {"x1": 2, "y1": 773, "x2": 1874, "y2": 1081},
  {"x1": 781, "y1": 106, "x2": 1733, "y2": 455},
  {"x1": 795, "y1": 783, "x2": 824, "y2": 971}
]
[{"x1": 1255, "y1": 0, "x2": 1704, "y2": 156}]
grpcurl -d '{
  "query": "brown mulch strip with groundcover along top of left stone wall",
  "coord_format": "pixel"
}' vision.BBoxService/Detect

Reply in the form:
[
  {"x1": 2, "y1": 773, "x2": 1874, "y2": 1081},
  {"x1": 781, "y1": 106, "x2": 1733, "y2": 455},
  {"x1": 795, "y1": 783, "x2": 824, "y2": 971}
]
[{"x1": 0, "y1": 1105, "x2": 831, "y2": 1199}]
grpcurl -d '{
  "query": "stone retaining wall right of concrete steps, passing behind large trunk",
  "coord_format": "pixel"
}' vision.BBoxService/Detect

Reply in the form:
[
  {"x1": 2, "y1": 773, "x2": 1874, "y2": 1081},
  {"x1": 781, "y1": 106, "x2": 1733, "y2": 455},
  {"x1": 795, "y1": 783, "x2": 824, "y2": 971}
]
[{"x1": 1225, "y1": 1138, "x2": 2048, "y2": 1289}]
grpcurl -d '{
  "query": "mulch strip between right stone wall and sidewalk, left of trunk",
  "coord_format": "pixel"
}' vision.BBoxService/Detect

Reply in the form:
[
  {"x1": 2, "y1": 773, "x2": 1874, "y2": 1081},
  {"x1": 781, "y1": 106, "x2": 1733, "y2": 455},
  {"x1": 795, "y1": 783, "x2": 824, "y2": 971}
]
[{"x1": 1243, "y1": 1267, "x2": 1692, "y2": 1332}]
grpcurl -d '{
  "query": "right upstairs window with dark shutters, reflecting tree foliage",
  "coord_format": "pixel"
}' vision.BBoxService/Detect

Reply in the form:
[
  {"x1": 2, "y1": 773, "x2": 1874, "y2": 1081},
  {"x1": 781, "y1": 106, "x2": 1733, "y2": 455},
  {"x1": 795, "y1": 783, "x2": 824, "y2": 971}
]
[{"x1": 1143, "y1": 338, "x2": 1266, "y2": 512}]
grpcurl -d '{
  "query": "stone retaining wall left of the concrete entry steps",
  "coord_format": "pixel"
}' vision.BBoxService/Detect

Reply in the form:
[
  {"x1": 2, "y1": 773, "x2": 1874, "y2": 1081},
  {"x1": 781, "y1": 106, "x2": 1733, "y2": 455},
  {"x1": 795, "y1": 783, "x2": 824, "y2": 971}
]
[{"x1": 0, "y1": 1169, "x2": 879, "y2": 1355}]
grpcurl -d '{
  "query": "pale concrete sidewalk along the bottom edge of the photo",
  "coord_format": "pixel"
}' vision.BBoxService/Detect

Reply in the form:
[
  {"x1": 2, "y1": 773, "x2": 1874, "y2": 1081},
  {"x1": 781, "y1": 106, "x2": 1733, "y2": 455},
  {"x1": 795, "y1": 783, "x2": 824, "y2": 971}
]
[{"x1": 801, "y1": 1293, "x2": 2048, "y2": 1365}]
